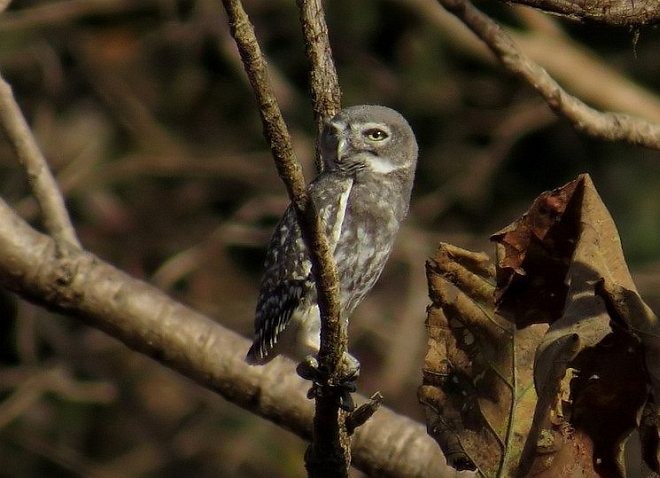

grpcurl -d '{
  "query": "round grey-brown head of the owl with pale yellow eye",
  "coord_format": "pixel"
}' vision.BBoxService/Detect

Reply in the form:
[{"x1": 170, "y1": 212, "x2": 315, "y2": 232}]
[{"x1": 321, "y1": 105, "x2": 417, "y2": 175}]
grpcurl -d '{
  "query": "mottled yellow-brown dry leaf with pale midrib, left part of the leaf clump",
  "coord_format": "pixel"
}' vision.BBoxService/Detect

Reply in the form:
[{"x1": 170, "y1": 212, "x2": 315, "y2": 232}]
[{"x1": 419, "y1": 244, "x2": 547, "y2": 476}]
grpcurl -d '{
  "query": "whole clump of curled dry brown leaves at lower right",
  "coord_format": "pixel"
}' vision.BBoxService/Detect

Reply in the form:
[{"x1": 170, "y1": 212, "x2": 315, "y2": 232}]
[{"x1": 420, "y1": 175, "x2": 660, "y2": 477}]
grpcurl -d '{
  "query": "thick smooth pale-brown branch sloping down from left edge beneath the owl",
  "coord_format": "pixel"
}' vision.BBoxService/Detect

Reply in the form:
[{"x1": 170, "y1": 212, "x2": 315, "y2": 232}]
[{"x1": 0, "y1": 200, "x2": 457, "y2": 478}]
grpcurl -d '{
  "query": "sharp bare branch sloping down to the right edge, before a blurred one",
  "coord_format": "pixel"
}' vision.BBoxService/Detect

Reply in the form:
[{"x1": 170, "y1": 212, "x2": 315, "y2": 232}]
[{"x1": 438, "y1": 0, "x2": 660, "y2": 149}]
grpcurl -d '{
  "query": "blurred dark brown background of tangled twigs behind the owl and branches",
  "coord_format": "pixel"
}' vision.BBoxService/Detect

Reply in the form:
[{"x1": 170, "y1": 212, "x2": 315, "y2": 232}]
[{"x1": 0, "y1": 0, "x2": 660, "y2": 477}]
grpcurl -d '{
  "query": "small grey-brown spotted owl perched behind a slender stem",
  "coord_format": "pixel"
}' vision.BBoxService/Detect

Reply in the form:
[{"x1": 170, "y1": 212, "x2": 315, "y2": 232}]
[{"x1": 246, "y1": 105, "x2": 417, "y2": 373}]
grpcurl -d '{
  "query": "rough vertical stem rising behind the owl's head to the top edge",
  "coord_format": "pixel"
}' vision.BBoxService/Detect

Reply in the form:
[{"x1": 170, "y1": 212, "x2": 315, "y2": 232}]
[{"x1": 297, "y1": 0, "x2": 341, "y2": 171}]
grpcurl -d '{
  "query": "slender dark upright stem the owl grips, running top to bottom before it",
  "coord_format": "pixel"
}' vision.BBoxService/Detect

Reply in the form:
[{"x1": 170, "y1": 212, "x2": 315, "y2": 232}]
[{"x1": 223, "y1": 0, "x2": 350, "y2": 476}]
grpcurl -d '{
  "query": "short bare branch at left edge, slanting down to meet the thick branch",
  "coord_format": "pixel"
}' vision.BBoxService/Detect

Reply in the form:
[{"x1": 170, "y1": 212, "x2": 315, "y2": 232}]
[{"x1": 0, "y1": 71, "x2": 80, "y2": 247}]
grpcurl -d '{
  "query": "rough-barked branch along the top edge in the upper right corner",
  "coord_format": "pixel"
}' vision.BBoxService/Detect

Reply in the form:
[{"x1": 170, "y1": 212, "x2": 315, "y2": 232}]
[{"x1": 505, "y1": 0, "x2": 660, "y2": 26}]
